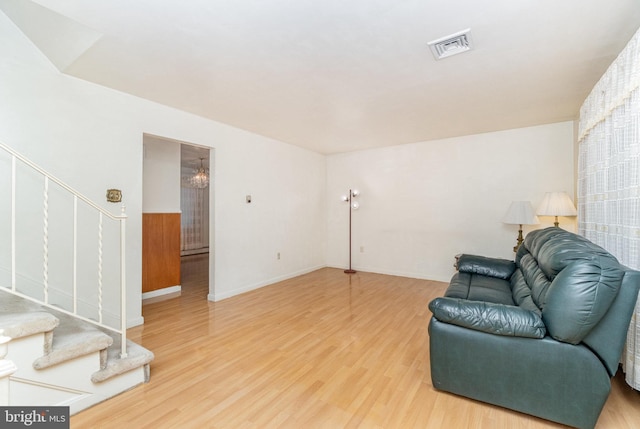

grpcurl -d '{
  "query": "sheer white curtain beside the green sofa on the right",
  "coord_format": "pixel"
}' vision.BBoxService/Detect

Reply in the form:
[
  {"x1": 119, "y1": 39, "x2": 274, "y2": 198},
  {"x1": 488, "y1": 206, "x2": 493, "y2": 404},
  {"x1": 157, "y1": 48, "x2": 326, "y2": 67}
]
[{"x1": 578, "y1": 25, "x2": 640, "y2": 389}]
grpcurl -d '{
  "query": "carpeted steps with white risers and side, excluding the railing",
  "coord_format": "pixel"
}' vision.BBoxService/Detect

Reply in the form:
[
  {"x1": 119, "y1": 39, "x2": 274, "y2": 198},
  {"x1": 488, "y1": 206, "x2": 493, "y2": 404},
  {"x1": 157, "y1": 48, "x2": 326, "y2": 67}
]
[{"x1": 0, "y1": 294, "x2": 153, "y2": 414}]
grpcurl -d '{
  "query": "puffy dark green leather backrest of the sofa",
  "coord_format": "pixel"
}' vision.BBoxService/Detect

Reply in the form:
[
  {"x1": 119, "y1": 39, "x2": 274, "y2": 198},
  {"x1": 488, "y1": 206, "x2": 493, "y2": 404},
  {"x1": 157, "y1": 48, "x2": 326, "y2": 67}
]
[{"x1": 511, "y1": 227, "x2": 624, "y2": 344}]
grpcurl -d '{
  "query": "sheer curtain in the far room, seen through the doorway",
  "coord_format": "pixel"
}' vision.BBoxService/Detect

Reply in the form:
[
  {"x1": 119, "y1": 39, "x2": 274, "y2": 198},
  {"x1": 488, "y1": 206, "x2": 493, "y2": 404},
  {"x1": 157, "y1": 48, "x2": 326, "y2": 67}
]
[{"x1": 180, "y1": 184, "x2": 209, "y2": 253}]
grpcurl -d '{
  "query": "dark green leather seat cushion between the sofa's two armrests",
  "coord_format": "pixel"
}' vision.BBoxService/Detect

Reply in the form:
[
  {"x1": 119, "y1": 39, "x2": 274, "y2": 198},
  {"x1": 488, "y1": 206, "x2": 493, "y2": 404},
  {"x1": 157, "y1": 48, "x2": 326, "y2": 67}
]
[{"x1": 445, "y1": 272, "x2": 515, "y2": 305}]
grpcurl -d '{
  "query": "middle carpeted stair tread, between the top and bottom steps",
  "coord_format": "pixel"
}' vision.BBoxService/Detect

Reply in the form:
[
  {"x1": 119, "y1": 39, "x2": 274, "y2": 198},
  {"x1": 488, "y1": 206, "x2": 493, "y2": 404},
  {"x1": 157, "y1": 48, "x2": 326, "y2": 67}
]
[{"x1": 33, "y1": 318, "x2": 113, "y2": 369}]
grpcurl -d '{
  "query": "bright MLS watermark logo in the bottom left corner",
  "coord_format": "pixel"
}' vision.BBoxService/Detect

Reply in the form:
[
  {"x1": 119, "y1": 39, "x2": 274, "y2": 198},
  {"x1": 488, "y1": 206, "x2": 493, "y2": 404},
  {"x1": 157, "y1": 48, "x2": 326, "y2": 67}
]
[{"x1": 0, "y1": 407, "x2": 69, "y2": 429}]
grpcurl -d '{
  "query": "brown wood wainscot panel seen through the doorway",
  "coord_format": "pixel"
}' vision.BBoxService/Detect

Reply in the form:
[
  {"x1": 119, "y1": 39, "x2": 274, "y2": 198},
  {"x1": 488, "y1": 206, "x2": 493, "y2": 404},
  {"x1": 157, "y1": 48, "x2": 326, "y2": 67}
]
[{"x1": 142, "y1": 213, "x2": 180, "y2": 292}]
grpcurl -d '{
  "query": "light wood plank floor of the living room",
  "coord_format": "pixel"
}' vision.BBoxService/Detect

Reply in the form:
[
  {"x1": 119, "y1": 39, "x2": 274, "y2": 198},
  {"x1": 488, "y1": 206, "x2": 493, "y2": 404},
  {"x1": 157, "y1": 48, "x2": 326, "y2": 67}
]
[{"x1": 71, "y1": 260, "x2": 640, "y2": 429}]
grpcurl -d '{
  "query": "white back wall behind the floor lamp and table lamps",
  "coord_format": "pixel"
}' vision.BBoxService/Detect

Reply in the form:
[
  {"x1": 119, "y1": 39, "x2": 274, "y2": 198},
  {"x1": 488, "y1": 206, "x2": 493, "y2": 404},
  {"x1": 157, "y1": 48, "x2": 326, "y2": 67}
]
[{"x1": 327, "y1": 122, "x2": 575, "y2": 281}]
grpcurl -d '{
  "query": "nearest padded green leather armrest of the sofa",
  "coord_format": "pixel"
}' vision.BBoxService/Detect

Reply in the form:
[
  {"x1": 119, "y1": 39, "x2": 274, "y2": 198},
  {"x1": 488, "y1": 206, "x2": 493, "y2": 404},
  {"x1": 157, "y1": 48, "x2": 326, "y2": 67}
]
[{"x1": 429, "y1": 297, "x2": 547, "y2": 338}]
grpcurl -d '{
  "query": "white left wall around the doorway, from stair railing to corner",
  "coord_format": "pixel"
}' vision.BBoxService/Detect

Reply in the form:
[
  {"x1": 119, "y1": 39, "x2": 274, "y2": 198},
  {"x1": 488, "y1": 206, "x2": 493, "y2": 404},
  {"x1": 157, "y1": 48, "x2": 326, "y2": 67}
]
[{"x1": 0, "y1": 13, "x2": 326, "y2": 325}]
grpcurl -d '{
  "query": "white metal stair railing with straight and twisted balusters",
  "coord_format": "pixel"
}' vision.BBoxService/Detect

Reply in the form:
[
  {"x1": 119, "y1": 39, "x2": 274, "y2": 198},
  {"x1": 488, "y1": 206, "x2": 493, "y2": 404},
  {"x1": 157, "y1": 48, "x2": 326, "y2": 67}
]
[{"x1": 0, "y1": 142, "x2": 127, "y2": 358}]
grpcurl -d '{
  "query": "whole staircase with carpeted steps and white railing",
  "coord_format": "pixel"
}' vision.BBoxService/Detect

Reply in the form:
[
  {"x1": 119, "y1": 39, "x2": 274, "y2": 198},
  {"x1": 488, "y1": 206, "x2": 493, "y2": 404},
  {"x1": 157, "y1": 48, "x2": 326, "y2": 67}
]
[{"x1": 0, "y1": 142, "x2": 154, "y2": 414}]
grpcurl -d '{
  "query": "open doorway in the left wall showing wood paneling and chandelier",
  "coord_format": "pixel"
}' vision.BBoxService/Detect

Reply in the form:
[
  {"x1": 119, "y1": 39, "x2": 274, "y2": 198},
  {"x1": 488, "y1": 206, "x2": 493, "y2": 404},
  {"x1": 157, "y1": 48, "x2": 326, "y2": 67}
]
[{"x1": 142, "y1": 134, "x2": 215, "y2": 304}]
